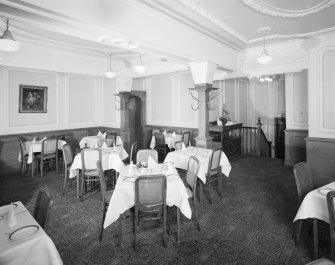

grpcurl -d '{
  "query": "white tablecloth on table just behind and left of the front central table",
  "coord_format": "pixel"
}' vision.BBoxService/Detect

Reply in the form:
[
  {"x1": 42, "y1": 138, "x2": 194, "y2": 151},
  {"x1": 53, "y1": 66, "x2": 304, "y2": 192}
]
[{"x1": 69, "y1": 146, "x2": 129, "y2": 178}]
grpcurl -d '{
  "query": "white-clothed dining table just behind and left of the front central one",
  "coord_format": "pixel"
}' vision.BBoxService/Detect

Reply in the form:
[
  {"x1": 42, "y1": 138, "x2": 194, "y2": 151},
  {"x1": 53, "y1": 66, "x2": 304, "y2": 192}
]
[{"x1": 69, "y1": 146, "x2": 129, "y2": 197}]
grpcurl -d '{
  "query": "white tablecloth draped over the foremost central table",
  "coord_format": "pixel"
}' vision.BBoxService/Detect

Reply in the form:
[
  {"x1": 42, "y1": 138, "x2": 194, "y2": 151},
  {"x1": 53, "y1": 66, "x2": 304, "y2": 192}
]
[{"x1": 104, "y1": 164, "x2": 192, "y2": 228}]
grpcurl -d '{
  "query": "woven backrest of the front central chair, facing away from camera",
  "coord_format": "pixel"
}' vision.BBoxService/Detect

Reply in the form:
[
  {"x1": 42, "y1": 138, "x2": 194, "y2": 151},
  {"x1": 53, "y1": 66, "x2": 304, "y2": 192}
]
[{"x1": 135, "y1": 174, "x2": 166, "y2": 209}]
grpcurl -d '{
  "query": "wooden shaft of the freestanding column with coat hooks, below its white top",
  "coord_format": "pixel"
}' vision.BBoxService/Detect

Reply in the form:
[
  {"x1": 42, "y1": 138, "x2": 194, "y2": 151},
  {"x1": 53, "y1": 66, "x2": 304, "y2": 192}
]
[{"x1": 190, "y1": 84, "x2": 217, "y2": 148}]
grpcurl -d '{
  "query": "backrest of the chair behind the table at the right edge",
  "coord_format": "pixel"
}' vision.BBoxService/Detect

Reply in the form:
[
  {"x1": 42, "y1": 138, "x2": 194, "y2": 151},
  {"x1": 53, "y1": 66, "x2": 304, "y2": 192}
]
[{"x1": 293, "y1": 162, "x2": 314, "y2": 203}]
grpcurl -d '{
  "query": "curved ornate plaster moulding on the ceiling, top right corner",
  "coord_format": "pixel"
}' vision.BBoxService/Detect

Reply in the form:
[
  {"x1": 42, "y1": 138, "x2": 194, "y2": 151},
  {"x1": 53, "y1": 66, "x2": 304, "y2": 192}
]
[{"x1": 240, "y1": 0, "x2": 335, "y2": 18}]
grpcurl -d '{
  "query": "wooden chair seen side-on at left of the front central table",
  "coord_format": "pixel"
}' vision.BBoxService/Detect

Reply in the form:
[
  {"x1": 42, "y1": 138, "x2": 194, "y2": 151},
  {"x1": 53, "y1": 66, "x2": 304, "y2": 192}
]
[{"x1": 97, "y1": 161, "x2": 115, "y2": 241}]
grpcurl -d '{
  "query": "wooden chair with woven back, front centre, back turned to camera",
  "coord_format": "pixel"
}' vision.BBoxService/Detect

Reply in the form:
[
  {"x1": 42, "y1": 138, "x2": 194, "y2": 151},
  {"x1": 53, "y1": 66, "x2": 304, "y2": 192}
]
[{"x1": 133, "y1": 175, "x2": 167, "y2": 251}]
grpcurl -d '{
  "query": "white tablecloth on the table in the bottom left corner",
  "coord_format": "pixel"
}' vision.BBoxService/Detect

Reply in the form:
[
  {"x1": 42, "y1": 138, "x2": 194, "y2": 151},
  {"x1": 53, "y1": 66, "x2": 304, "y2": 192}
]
[{"x1": 0, "y1": 202, "x2": 63, "y2": 265}]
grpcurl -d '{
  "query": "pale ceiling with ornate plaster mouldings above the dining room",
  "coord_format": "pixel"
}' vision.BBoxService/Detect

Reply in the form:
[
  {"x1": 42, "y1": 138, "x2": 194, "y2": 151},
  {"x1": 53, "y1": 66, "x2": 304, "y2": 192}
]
[{"x1": 0, "y1": 0, "x2": 335, "y2": 74}]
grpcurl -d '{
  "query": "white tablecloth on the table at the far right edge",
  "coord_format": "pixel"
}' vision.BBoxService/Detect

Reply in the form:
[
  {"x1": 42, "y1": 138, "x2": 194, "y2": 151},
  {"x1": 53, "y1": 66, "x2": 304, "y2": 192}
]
[{"x1": 293, "y1": 182, "x2": 335, "y2": 223}]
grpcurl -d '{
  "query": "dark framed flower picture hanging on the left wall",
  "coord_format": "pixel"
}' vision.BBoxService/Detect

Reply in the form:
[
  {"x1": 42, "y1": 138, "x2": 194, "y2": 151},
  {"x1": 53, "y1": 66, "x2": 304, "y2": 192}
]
[{"x1": 19, "y1": 85, "x2": 48, "y2": 113}]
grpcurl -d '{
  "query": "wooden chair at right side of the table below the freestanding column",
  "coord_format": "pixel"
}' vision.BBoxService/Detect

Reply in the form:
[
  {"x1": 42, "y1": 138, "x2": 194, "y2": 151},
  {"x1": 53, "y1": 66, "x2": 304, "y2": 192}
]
[{"x1": 200, "y1": 147, "x2": 222, "y2": 204}]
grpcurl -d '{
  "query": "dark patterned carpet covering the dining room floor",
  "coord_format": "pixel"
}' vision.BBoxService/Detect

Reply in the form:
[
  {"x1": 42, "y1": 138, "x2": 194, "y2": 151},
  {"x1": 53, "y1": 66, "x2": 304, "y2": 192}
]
[{"x1": 0, "y1": 157, "x2": 329, "y2": 265}]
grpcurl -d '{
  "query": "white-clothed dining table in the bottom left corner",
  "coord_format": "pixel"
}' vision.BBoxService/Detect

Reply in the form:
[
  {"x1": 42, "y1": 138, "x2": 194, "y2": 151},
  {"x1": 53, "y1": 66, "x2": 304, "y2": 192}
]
[{"x1": 0, "y1": 201, "x2": 63, "y2": 265}]
